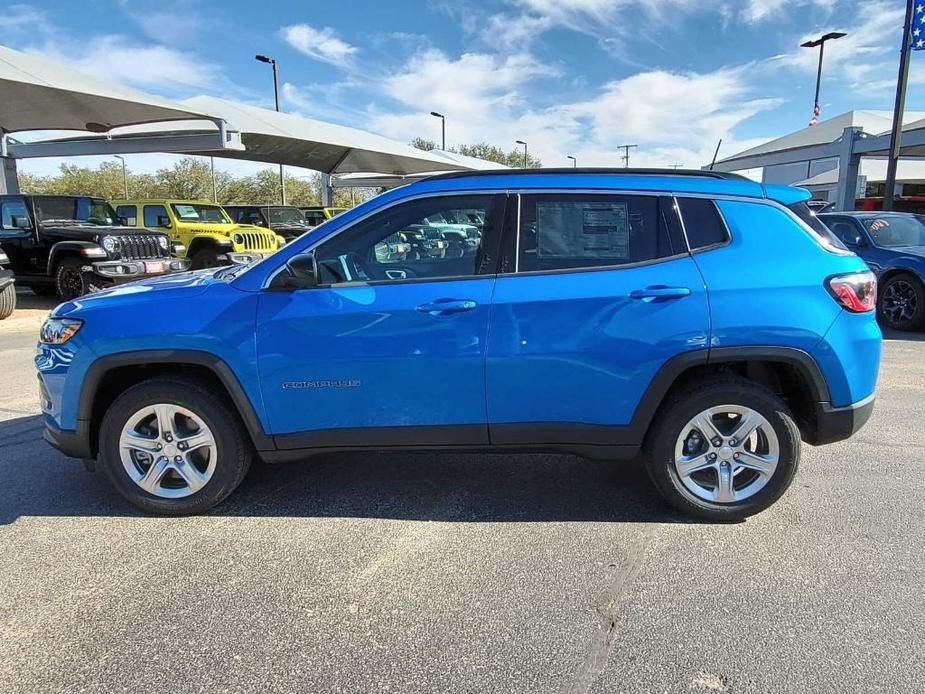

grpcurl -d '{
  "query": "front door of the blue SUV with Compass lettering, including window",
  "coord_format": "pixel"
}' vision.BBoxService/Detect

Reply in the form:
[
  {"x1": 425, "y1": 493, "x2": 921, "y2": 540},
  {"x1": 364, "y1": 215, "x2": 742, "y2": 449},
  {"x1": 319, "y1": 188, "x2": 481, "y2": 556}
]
[{"x1": 257, "y1": 195, "x2": 505, "y2": 448}]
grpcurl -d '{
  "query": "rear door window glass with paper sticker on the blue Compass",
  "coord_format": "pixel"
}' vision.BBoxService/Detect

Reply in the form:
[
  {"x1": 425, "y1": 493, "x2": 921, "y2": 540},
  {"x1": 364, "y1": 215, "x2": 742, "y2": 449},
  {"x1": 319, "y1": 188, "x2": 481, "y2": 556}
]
[{"x1": 518, "y1": 194, "x2": 673, "y2": 272}]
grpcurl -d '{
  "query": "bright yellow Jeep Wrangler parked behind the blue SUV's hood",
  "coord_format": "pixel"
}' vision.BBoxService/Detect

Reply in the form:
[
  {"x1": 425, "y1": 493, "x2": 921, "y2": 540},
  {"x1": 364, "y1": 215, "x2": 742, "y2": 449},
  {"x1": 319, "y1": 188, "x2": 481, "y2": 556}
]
[{"x1": 112, "y1": 200, "x2": 286, "y2": 269}]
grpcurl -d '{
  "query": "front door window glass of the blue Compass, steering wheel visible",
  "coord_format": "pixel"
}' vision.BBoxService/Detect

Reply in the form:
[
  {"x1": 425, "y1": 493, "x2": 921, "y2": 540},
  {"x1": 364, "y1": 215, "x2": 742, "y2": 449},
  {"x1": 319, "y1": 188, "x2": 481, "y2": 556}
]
[{"x1": 315, "y1": 195, "x2": 494, "y2": 284}]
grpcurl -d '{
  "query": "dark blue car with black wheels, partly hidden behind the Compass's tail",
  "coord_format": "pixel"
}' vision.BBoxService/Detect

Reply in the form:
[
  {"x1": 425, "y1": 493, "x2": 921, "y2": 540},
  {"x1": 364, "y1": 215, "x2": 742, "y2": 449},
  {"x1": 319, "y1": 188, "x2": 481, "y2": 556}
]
[{"x1": 819, "y1": 212, "x2": 925, "y2": 330}]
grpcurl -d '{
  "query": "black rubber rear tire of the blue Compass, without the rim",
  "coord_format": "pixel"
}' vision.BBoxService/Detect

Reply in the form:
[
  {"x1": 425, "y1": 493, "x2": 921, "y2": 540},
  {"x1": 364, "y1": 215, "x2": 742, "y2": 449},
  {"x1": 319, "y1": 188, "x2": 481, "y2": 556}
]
[{"x1": 645, "y1": 376, "x2": 800, "y2": 522}]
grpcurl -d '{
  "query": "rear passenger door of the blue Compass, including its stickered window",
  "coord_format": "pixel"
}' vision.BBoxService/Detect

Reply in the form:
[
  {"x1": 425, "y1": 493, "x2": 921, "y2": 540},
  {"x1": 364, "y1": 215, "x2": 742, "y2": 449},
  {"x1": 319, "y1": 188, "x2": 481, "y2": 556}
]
[{"x1": 486, "y1": 193, "x2": 710, "y2": 444}]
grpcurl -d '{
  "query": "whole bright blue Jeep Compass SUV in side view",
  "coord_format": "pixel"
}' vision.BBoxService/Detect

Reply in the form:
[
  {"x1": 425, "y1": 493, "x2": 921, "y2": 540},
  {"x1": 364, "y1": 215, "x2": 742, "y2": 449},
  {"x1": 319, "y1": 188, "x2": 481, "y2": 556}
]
[{"x1": 35, "y1": 169, "x2": 881, "y2": 520}]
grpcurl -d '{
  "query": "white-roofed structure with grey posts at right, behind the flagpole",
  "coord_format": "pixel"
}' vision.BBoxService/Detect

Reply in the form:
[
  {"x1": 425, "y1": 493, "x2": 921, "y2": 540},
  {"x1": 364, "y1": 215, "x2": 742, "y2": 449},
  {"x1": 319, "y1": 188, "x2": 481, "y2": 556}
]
[{"x1": 714, "y1": 110, "x2": 925, "y2": 209}]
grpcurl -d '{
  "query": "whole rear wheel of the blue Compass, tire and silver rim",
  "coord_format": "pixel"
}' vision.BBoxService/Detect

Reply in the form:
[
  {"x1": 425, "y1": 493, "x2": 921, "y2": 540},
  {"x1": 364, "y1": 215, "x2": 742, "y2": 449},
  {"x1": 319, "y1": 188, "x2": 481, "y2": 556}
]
[{"x1": 647, "y1": 377, "x2": 800, "y2": 521}]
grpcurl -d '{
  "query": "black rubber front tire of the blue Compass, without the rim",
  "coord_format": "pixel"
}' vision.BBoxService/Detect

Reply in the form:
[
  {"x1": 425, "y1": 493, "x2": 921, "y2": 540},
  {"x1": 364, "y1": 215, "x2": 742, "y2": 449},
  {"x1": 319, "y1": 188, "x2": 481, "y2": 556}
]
[{"x1": 99, "y1": 378, "x2": 254, "y2": 516}]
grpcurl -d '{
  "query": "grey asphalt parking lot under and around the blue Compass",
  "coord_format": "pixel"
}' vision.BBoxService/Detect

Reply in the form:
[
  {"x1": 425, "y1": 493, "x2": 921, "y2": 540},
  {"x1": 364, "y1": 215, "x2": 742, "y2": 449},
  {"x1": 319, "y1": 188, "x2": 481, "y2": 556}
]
[{"x1": 0, "y1": 294, "x2": 925, "y2": 693}]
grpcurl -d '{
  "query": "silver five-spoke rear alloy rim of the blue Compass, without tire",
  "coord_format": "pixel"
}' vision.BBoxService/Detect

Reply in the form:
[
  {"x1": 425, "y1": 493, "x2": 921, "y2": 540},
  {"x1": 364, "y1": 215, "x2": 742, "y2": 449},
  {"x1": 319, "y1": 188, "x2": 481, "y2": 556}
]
[{"x1": 674, "y1": 405, "x2": 780, "y2": 504}]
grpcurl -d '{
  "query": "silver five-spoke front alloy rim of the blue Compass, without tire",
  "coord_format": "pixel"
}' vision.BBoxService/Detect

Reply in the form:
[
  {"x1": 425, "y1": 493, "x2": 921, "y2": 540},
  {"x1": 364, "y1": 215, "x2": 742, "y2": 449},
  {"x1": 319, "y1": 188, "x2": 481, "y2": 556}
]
[{"x1": 119, "y1": 403, "x2": 218, "y2": 499}]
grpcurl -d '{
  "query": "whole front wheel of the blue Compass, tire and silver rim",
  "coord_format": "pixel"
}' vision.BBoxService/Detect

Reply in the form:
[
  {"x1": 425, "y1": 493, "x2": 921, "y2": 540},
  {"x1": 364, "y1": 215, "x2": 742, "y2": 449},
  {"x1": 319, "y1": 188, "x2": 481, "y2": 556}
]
[{"x1": 100, "y1": 378, "x2": 253, "y2": 515}]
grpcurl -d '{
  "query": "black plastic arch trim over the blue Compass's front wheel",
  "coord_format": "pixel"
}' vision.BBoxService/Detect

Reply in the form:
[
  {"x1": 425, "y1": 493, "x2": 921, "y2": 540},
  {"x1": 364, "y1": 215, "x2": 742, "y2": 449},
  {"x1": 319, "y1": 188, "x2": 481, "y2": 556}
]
[{"x1": 77, "y1": 349, "x2": 275, "y2": 457}]
